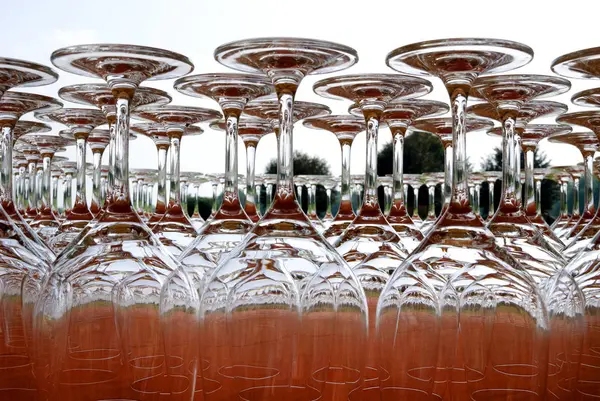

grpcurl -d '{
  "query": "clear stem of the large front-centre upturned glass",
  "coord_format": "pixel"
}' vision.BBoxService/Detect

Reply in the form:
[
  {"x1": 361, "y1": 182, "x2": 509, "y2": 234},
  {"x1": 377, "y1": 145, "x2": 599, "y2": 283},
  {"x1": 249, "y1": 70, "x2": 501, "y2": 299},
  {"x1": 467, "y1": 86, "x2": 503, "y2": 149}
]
[{"x1": 276, "y1": 92, "x2": 295, "y2": 200}]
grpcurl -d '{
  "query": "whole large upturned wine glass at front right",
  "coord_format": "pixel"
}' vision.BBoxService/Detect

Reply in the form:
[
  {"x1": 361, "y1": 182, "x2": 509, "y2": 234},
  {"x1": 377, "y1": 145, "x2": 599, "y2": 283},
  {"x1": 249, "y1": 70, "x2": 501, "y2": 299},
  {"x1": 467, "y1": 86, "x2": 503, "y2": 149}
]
[{"x1": 377, "y1": 38, "x2": 548, "y2": 401}]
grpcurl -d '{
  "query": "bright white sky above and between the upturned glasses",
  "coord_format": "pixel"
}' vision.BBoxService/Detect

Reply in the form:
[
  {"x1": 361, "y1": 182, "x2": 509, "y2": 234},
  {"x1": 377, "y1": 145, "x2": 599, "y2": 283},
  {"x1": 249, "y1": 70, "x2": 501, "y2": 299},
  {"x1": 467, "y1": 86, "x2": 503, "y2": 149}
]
[{"x1": 0, "y1": 0, "x2": 600, "y2": 195}]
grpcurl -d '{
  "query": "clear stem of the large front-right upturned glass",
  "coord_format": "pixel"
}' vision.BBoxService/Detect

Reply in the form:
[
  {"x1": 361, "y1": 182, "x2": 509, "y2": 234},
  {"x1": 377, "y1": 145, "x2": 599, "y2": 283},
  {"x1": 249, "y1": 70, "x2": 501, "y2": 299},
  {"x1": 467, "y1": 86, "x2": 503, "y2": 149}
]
[{"x1": 450, "y1": 86, "x2": 471, "y2": 212}]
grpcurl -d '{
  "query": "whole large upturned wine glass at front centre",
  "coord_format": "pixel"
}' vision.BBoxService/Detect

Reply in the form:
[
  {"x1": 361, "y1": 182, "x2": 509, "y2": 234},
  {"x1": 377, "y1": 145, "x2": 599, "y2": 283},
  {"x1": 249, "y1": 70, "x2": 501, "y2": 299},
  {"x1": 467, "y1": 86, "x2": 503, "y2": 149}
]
[{"x1": 176, "y1": 38, "x2": 367, "y2": 400}]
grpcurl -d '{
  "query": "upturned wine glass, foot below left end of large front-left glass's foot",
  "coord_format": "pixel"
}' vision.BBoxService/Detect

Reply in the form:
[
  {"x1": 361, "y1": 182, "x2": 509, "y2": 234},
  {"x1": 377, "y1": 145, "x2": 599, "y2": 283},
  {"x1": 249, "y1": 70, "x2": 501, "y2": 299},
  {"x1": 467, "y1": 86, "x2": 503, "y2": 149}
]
[{"x1": 32, "y1": 108, "x2": 106, "y2": 250}]
